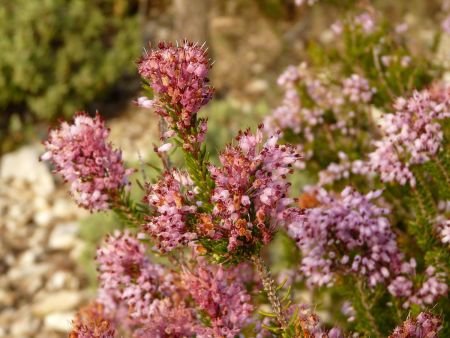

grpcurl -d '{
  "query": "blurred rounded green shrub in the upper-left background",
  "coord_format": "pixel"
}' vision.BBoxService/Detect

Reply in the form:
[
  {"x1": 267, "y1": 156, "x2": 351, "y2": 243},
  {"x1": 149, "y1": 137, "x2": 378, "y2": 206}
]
[{"x1": 0, "y1": 0, "x2": 140, "y2": 151}]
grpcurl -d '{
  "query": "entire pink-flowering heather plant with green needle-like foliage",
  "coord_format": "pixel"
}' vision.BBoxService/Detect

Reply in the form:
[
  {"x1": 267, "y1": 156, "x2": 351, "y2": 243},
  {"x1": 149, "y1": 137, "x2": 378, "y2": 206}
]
[{"x1": 42, "y1": 1, "x2": 450, "y2": 338}]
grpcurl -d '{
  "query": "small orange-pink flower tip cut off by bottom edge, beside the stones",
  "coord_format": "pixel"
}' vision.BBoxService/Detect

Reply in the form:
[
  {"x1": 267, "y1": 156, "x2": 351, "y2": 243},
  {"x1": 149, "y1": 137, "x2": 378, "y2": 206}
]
[{"x1": 69, "y1": 303, "x2": 116, "y2": 338}]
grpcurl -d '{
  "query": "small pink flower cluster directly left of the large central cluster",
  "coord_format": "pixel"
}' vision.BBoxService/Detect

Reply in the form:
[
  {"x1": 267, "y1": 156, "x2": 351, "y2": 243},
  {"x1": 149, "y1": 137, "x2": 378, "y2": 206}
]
[{"x1": 144, "y1": 171, "x2": 197, "y2": 252}]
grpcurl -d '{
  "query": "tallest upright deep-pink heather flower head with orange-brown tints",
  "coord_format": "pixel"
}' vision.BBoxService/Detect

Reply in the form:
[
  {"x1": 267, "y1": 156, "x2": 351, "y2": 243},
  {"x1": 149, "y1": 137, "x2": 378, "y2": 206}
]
[{"x1": 138, "y1": 41, "x2": 213, "y2": 131}]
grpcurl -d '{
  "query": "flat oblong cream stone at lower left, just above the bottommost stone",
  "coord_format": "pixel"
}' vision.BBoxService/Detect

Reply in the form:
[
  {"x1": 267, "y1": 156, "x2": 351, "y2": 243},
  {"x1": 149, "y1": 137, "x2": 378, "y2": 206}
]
[{"x1": 31, "y1": 291, "x2": 82, "y2": 317}]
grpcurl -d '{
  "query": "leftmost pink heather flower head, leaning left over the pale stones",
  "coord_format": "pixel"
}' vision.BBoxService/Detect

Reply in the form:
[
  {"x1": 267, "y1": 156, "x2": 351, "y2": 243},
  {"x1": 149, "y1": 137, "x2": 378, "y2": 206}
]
[{"x1": 41, "y1": 113, "x2": 132, "y2": 211}]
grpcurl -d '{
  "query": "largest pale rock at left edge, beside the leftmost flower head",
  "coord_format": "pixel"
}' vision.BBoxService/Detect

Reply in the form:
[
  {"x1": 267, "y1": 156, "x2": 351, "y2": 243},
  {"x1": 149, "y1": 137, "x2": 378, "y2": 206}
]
[{"x1": 0, "y1": 145, "x2": 55, "y2": 196}]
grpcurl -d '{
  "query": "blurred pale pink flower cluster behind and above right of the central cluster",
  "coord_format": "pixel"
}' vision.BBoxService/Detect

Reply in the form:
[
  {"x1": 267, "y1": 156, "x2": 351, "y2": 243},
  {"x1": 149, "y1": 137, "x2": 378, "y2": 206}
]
[{"x1": 264, "y1": 63, "x2": 375, "y2": 158}]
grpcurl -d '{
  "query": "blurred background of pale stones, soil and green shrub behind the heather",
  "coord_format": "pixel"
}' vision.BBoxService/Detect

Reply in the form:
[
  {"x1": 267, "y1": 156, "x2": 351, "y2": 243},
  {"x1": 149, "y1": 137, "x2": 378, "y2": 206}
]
[{"x1": 0, "y1": 0, "x2": 441, "y2": 338}]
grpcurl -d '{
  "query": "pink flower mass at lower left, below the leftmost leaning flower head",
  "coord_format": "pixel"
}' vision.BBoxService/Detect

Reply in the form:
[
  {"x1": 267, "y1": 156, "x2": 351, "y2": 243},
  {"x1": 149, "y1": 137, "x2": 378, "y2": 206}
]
[{"x1": 97, "y1": 232, "x2": 196, "y2": 337}]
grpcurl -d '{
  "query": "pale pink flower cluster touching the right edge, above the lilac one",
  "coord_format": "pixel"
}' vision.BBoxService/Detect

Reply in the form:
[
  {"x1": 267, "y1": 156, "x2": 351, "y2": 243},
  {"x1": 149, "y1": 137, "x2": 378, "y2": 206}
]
[{"x1": 369, "y1": 85, "x2": 450, "y2": 186}]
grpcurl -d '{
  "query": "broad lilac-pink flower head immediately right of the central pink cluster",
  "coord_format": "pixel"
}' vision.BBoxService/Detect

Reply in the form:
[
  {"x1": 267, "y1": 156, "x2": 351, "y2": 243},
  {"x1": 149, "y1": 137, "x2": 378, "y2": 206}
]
[{"x1": 287, "y1": 187, "x2": 402, "y2": 287}]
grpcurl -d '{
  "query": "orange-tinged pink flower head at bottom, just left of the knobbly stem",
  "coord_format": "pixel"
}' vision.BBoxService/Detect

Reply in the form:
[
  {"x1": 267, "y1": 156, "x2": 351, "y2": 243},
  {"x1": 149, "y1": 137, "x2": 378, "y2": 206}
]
[{"x1": 183, "y1": 263, "x2": 253, "y2": 338}]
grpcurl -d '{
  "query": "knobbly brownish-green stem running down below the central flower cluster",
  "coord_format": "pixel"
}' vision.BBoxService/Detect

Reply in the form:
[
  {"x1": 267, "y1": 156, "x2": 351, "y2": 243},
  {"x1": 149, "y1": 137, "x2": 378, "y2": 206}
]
[{"x1": 252, "y1": 255, "x2": 287, "y2": 329}]
